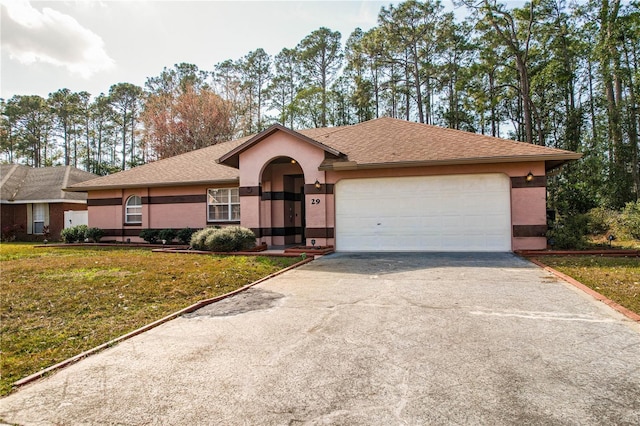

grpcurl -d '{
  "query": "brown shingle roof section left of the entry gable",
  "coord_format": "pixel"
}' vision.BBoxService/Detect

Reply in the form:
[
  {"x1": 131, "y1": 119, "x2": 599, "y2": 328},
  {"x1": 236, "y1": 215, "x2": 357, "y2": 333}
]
[{"x1": 67, "y1": 138, "x2": 249, "y2": 191}]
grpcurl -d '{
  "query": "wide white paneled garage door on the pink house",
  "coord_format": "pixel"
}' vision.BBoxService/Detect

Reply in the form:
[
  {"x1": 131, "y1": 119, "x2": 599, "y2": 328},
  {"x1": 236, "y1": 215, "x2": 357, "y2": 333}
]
[{"x1": 335, "y1": 174, "x2": 511, "y2": 251}]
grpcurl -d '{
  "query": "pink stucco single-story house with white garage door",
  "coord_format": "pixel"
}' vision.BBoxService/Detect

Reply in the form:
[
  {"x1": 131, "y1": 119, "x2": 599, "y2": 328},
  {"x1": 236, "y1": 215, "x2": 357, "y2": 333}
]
[{"x1": 68, "y1": 118, "x2": 580, "y2": 251}]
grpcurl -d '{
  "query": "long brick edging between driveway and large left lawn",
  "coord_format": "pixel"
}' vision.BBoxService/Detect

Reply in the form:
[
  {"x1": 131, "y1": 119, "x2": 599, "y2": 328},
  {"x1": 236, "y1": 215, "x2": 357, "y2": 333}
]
[{"x1": 12, "y1": 256, "x2": 314, "y2": 388}]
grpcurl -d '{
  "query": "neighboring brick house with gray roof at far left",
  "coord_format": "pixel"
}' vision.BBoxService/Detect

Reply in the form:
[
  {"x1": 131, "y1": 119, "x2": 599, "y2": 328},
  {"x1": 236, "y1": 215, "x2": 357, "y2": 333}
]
[{"x1": 0, "y1": 164, "x2": 98, "y2": 241}]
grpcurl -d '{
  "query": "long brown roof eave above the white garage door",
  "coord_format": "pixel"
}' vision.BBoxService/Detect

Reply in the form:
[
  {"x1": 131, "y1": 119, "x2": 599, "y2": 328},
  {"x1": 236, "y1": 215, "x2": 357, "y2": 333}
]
[{"x1": 319, "y1": 153, "x2": 582, "y2": 171}]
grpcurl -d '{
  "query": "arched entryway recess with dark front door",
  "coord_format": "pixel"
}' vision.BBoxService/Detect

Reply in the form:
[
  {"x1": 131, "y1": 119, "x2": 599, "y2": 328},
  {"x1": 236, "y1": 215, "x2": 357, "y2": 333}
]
[{"x1": 260, "y1": 156, "x2": 306, "y2": 246}]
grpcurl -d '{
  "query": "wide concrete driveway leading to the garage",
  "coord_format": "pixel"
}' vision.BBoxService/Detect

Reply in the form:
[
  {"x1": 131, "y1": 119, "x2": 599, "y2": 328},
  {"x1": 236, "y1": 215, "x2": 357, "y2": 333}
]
[{"x1": 0, "y1": 254, "x2": 640, "y2": 425}]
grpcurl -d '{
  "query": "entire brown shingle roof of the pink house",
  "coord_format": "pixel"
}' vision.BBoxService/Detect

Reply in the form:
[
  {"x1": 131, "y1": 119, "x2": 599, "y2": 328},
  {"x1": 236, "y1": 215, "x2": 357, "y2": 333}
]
[{"x1": 68, "y1": 118, "x2": 580, "y2": 191}]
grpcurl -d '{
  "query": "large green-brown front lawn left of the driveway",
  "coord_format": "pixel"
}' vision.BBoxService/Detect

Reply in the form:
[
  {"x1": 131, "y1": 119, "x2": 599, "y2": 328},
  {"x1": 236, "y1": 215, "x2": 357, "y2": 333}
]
[{"x1": 0, "y1": 243, "x2": 300, "y2": 395}]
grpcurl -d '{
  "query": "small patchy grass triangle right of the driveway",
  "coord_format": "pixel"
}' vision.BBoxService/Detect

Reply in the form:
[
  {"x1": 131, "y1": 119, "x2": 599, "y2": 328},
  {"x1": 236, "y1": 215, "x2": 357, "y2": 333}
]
[{"x1": 538, "y1": 256, "x2": 640, "y2": 315}]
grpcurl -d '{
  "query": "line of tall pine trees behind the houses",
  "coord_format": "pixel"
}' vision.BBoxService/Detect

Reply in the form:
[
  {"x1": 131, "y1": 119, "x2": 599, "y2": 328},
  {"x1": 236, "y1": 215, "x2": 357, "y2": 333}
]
[{"x1": 0, "y1": 0, "x2": 640, "y2": 212}]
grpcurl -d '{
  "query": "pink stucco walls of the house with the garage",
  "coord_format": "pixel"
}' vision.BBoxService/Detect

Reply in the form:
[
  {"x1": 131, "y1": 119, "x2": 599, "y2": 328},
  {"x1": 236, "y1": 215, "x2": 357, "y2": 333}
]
[{"x1": 89, "y1": 132, "x2": 546, "y2": 250}]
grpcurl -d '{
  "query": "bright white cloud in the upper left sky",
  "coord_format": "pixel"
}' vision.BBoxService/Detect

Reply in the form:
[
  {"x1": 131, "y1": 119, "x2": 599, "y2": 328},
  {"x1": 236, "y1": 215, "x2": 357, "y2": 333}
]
[{"x1": 0, "y1": 0, "x2": 114, "y2": 78}]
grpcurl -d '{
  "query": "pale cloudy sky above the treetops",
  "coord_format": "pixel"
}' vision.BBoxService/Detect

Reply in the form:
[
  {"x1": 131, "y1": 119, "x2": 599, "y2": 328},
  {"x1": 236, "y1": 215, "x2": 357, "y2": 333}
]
[{"x1": 0, "y1": 0, "x2": 444, "y2": 99}]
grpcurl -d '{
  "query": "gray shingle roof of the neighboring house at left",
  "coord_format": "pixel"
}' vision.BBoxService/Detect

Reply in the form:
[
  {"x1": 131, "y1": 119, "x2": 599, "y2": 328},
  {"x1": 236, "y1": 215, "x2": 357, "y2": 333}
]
[{"x1": 0, "y1": 164, "x2": 98, "y2": 204}]
